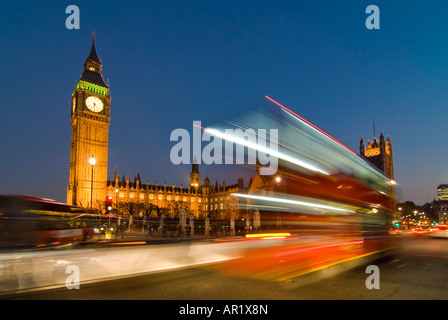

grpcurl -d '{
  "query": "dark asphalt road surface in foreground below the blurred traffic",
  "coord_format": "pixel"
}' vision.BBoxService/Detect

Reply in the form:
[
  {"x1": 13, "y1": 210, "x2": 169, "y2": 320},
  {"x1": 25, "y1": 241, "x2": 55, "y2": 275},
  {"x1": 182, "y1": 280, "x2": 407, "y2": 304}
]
[{"x1": 3, "y1": 236, "x2": 448, "y2": 300}]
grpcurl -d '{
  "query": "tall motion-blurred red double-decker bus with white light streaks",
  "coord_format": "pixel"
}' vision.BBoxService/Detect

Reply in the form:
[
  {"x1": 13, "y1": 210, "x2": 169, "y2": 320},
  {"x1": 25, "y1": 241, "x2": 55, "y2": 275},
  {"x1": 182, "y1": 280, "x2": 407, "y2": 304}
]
[{"x1": 214, "y1": 99, "x2": 399, "y2": 279}]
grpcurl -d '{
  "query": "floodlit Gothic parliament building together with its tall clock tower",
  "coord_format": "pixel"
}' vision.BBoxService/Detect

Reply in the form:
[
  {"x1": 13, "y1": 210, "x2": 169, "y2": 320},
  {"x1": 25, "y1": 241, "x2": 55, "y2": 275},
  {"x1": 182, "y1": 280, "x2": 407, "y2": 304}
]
[{"x1": 67, "y1": 38, "x2": 245, "y2": 219}]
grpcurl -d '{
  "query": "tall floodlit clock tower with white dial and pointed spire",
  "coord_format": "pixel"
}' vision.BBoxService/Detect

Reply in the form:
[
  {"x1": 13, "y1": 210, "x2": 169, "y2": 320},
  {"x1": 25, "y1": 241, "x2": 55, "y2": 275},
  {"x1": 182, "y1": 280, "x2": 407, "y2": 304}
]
[{"x1": 67, "y1": 37, "x2": 111, "y2": 209}]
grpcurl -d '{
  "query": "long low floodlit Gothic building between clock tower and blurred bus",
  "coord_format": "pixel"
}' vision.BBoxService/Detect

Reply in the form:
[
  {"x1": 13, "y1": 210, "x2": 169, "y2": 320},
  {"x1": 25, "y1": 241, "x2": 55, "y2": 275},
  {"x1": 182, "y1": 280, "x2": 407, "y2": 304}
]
[{"x1": 107, "y1": 164, "x2": 246, "y2": 220}]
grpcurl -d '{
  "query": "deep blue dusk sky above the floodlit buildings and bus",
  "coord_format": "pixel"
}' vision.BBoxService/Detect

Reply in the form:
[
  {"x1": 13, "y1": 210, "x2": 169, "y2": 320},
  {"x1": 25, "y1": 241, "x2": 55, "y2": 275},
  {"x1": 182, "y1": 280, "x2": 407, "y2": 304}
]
[{"x1": 0, "y1": 0, "x2": 448, "y2": 204}]
